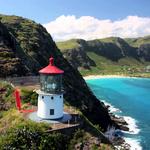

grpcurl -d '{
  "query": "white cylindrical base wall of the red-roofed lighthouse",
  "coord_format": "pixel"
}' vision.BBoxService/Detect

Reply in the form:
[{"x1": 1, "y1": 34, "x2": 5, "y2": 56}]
[{"x1": 37, "y1": 92, "x2": 63, "y2": 119}]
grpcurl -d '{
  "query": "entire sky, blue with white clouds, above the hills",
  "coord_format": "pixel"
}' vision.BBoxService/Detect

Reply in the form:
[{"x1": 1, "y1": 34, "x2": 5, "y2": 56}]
[{"x1": 0, "y1": 0, "x2": 150, "y2": 41}]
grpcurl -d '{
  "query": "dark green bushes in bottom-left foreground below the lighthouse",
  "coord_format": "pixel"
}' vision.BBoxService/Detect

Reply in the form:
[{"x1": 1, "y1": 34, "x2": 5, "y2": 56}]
[{"x1": 0, "y1": 121, "x2": 68, "y2": 150}]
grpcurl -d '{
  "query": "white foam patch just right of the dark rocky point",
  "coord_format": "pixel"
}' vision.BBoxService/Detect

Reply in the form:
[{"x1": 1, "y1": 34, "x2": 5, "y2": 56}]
[{"x1": 123, "y1": 116, "x2": 140, "y2": 134}]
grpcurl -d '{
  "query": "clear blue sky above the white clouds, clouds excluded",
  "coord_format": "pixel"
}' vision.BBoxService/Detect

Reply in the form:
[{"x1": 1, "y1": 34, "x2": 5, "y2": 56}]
[{"x1": 0, "y1": 0, "x2": 150, "y2": 24}]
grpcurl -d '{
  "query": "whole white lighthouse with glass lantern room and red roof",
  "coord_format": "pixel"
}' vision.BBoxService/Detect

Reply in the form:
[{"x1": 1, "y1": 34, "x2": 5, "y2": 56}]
[{"x1": 37, "y1": 57, "x2": 64, "y2": 119}]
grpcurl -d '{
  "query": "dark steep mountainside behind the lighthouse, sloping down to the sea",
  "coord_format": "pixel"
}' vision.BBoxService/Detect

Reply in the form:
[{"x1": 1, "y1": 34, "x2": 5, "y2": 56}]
[{"x1": 0, "y1": 15, "x2": 115, "y2": 129}]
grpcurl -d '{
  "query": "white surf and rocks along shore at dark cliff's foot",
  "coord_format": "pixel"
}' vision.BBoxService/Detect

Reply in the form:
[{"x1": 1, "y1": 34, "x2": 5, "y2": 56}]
[{"x1": 102, "y1": 100, "x2": 142, "y2": 150}]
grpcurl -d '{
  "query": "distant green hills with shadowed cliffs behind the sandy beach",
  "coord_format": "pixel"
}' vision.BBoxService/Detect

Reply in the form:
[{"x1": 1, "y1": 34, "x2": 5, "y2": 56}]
[{"x1": 57, "y1": 36, "x2": 150, "y2": 75}]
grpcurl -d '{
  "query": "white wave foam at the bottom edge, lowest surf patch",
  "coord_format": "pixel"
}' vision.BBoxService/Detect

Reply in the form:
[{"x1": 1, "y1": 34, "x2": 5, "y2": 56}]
[{"x1": 124, "y1": 138, "x2": 142, "y2": 150}]
